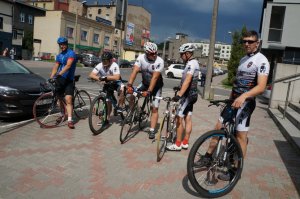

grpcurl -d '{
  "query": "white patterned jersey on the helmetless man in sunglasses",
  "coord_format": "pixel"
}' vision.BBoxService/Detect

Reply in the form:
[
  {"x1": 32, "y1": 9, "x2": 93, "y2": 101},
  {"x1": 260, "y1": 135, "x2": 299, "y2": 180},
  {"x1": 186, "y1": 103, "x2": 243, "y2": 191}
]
[{"x1": 232, "y1": 52, "x2": 270, "y2": 95}]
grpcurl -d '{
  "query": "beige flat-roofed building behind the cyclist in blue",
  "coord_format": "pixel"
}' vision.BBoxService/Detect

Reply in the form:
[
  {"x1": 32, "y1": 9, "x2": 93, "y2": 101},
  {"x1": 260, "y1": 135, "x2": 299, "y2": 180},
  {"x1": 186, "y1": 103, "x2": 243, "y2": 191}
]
[{"x1": 34, "y1": 11, "x2": 114, "y2": 59}]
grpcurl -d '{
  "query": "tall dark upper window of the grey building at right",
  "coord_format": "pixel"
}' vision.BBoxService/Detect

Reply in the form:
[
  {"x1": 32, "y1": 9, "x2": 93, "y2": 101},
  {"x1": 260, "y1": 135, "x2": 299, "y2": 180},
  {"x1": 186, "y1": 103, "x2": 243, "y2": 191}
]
[{"x1": 268, "y1": 6, "x2": 285, "y2": 42}]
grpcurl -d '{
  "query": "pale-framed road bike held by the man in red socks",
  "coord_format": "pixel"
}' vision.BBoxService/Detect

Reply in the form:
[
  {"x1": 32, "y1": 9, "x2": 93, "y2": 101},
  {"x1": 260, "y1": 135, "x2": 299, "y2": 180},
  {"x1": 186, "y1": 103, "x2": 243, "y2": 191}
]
[{"x1": 156, "y1": 89, "x2": 179, "y2": 162}]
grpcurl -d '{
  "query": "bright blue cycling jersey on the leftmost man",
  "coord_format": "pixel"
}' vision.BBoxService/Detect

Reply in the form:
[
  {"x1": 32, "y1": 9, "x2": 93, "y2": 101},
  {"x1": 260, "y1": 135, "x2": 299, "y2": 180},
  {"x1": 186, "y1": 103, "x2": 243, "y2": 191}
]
[{"x1": 56, "y1": 49, "x2": 77, "y2": 80}]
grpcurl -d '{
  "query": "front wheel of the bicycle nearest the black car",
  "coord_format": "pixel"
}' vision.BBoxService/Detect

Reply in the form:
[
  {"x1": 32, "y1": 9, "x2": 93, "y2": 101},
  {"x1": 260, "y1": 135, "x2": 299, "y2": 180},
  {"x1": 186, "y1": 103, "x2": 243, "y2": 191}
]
[{"x1": 32, "y1": 93, "x2": 66, "y2": 128}]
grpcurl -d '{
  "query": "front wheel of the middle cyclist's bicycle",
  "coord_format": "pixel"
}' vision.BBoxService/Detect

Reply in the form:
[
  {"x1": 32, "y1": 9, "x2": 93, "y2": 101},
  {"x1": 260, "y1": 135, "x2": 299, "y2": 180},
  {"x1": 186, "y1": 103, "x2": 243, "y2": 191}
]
[{"x1": 120, "y1": 106, "x2": 138, "y2": 144}]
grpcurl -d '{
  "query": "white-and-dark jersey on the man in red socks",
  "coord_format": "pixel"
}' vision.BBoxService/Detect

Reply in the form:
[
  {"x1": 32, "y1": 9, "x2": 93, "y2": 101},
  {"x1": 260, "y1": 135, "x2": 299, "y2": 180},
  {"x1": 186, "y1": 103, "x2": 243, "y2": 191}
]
[{"x1": 180, "y1": 59, "x2": 200, "y2": 102}]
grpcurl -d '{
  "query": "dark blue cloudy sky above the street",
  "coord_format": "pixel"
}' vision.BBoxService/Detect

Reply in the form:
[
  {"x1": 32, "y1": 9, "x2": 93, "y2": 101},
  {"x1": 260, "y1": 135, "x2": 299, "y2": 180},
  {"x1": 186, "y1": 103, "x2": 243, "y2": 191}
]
[{"x1": 95, "y1": 0, "x2": 263, "y2": 43}]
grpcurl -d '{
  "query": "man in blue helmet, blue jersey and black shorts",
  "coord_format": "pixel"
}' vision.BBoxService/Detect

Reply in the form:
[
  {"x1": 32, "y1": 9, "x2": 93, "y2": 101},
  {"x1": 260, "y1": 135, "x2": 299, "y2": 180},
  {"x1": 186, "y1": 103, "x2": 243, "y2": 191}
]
[{"x1": 50, "y1": 37, "x2": 77, "y2": 129}]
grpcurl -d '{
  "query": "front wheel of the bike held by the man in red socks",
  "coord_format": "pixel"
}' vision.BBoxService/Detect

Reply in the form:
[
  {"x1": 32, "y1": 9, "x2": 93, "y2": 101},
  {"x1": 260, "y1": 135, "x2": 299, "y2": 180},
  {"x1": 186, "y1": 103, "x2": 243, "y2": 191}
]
[{"x1": 156, "y1": 115, "x2": 169, "y2": 162}]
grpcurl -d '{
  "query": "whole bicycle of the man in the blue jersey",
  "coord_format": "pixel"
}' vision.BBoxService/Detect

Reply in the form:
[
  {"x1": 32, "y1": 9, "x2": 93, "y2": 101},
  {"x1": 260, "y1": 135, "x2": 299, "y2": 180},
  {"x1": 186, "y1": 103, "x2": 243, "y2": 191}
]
[{"x1": 33, "y1": 75, "x2": 91, "y2": 128}]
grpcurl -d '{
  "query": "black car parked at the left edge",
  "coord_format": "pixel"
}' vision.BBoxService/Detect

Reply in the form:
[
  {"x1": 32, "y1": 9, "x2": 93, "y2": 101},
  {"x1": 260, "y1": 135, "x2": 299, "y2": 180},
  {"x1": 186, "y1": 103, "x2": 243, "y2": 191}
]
[{"x1": 0, "y1": 56, "x2": 46, "y2": 118}]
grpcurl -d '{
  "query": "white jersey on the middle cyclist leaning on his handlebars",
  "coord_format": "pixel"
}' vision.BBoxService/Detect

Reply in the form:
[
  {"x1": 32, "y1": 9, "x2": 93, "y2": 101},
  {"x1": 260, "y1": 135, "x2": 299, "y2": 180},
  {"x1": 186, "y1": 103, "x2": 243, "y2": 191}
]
[{"x1": 134, "y1": 54, "x2": 164, "y2": 88}]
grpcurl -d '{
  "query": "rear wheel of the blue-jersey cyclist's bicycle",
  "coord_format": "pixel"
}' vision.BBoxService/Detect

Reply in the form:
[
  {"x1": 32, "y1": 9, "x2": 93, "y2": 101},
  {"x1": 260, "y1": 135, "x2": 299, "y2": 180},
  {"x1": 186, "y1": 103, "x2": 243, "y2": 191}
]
[{"x1": 73, "y1": 90, "x2": 91, "y2": 119}]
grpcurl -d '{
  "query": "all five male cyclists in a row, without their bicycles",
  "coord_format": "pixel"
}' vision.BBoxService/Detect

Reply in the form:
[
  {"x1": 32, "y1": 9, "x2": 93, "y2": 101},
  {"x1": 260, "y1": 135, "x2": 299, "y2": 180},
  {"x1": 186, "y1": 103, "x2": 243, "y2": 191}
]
[{"x1": 50, "y1": 31, "x2": 270, "y2": 180}]
